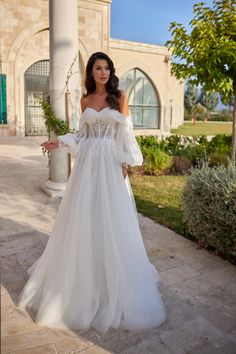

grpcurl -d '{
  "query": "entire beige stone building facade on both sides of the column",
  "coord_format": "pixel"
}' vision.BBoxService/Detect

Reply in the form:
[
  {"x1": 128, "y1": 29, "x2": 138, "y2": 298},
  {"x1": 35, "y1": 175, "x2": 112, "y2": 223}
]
[{"x1": 0, "y1": 0, "x2": 183, "y2": 136}]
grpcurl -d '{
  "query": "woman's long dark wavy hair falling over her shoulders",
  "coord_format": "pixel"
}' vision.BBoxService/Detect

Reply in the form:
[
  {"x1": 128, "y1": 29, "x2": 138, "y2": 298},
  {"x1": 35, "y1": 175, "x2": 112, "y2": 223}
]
[{"x1": 84, "y1": 52, "x2": 121, "y2": 110}]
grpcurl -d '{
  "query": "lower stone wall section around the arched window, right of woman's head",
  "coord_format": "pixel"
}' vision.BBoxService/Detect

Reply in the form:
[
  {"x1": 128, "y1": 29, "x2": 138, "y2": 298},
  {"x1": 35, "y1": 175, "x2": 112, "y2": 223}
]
[{"x1": 109, "y1": 39, "x2": 184, "y2": 135}]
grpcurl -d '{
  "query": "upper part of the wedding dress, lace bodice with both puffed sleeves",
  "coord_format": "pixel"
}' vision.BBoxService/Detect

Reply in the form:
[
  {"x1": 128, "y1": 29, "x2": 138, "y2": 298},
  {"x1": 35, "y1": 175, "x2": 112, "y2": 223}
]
[{"x1": 58, "y1": 107, "x2": 143, "y2": 166}]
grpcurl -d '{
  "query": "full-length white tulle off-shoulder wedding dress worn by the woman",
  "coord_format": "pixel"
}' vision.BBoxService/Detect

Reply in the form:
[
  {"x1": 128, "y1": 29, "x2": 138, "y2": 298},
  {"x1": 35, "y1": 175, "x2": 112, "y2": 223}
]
[{"x1": 19, "y1": 107, "x2": 166, "y2": 333}]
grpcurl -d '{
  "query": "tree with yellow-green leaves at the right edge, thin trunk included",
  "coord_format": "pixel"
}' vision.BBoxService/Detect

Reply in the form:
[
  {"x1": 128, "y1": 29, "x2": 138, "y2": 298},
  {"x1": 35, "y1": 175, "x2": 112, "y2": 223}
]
[{"x1": 166, "y1": 0, "x2": 236, "y2": 161}]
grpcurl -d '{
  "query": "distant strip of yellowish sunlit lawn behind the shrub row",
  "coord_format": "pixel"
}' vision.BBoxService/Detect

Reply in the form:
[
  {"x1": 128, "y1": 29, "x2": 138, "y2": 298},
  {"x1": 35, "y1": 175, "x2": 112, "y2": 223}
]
[{"x1": 171, "y1": 122, "x2": 232, "y2": 135}]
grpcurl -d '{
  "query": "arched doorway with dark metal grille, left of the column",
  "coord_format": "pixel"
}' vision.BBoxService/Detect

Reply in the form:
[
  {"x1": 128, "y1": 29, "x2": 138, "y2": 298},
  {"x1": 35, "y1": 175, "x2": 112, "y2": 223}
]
[{"x1": 24, "y1": 60, "x2": 49, "y2": 135}]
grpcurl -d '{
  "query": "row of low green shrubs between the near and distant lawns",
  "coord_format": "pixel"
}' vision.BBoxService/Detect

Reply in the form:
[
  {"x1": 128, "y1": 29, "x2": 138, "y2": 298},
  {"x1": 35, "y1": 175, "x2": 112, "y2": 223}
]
[{"x1": 136, "y1": 134, "x2": 231, "y2": 175}]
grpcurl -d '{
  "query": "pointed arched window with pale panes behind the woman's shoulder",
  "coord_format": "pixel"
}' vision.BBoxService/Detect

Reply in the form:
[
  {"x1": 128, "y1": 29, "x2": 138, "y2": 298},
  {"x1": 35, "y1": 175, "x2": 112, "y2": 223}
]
[{"x1": 120, "y1": 68, "x2": 160, "y2": 129}]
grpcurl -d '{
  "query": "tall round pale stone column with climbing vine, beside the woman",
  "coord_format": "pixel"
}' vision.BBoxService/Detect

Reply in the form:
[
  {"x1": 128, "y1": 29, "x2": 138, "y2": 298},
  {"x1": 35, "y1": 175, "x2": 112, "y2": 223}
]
[{"x1": 45, "y1": 0, "x2": 79, "y2": 196}]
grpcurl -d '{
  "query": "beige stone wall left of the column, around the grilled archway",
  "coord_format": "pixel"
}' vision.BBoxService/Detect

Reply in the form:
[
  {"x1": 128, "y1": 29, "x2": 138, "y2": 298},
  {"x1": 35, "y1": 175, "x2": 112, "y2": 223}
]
[{"x1": 0, "y1": 0, "x2": 49, "y2": 135}]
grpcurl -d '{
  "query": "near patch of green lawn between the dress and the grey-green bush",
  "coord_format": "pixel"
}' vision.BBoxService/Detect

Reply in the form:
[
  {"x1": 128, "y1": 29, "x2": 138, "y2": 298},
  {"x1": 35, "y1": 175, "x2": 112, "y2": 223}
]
[{"x1": 130, "y1": 175, "x2": 189, "y2": 237}]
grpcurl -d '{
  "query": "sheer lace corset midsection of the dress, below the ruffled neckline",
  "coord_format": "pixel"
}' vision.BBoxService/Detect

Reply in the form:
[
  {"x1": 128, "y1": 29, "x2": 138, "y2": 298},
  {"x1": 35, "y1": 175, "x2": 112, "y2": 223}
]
[{"x1": 88, "y1": 119, "x2": 117, "y2": 139}]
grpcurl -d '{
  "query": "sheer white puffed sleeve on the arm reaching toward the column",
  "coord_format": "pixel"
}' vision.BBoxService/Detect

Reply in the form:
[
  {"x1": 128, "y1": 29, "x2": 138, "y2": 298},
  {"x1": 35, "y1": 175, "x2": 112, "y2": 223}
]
[{"x1": 57, "y1": 119, "x2": 88, "y2": 156}]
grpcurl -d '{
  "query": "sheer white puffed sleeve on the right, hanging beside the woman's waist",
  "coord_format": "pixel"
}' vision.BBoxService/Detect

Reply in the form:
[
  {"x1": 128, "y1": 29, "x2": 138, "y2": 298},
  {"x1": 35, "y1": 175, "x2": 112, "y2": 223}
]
[{"x1": 116, "y1": 114, "x2": 143, "y2": 166}]
